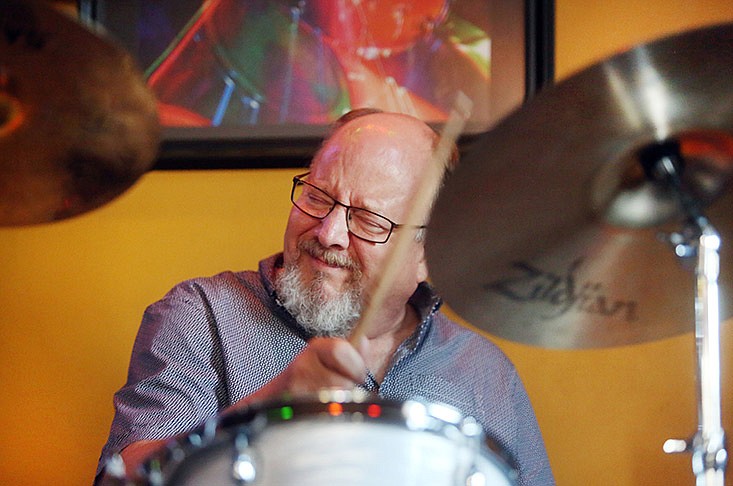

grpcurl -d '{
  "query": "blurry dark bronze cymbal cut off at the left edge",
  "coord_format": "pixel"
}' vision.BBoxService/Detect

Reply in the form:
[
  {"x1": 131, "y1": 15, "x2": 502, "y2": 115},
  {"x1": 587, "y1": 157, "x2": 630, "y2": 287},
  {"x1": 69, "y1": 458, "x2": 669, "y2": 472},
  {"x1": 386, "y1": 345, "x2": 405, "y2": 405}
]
[{"x1": 0, "y1": 0, "x2": 160, "y2": 226}]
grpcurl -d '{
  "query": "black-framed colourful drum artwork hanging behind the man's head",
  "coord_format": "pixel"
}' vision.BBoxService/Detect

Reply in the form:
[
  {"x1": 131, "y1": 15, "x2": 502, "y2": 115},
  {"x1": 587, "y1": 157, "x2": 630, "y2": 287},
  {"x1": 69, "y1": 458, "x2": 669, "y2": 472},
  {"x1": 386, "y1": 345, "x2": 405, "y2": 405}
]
[{"x1": 79, "y1": 0, "x2": 554, "y2": 169}]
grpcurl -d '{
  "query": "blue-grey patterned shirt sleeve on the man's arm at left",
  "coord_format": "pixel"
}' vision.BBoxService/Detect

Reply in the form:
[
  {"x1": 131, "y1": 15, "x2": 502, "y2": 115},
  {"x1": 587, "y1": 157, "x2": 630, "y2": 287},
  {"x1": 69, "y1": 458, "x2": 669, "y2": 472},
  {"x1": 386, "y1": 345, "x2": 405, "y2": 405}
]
[{"x1": 97, "y1": 282, "x2": 228, "y2": 473}]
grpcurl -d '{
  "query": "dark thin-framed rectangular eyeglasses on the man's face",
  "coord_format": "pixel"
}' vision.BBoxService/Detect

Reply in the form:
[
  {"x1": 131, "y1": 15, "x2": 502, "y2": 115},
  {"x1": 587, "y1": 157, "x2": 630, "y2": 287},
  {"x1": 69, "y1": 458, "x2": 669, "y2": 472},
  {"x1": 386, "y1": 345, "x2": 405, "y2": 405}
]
[{"x1": 290, "y1": 172, "x2": 427, "y2": 243}]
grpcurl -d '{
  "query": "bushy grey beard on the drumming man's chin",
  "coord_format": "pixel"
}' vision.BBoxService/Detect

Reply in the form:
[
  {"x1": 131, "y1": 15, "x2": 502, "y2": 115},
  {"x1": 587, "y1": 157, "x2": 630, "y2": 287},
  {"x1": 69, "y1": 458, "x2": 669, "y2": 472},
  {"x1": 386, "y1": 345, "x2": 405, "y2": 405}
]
[{"x1": 275, "y1": 265, "x2": 361, "y2": 337}]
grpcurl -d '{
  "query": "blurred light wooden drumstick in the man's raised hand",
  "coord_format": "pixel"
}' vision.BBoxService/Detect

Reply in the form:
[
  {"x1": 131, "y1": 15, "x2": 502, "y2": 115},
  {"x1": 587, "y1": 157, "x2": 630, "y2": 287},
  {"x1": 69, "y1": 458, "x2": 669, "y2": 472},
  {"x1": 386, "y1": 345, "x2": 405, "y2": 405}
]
[{"x1": 349, "y1": 92, "x2": 473, "y2": 346}]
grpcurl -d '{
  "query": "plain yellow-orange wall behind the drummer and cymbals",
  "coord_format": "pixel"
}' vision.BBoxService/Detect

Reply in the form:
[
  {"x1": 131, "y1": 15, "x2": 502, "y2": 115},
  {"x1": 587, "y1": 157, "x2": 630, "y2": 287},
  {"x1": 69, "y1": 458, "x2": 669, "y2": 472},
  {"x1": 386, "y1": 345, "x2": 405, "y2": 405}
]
[{"x1": 0, "y1": 0, "x2": 733, "y2": 486}]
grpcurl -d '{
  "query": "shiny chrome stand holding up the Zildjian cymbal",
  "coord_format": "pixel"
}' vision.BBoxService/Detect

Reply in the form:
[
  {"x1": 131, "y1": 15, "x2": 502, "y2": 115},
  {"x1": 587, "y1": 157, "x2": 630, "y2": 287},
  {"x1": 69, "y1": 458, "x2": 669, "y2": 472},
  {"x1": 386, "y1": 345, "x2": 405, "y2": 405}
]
[{"x1": 653, "y1": 148, "x2": 728, "y2": 486}]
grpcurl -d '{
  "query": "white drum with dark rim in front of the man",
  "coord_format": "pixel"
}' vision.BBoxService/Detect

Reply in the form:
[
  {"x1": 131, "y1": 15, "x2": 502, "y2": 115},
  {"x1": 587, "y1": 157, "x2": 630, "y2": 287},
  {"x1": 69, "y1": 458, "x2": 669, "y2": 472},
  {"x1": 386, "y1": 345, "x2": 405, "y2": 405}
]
[{"x1": 139, "y1": 390, "x2": 516, "y2": 486}]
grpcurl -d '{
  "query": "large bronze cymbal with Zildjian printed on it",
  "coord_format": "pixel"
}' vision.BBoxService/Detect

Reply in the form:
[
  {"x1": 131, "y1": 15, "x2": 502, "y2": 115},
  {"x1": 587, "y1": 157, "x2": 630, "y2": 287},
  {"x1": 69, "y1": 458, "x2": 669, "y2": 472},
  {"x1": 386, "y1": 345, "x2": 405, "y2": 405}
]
[{"x1": 426, "y1": 24, "x2": 733, "y2": 349}]
